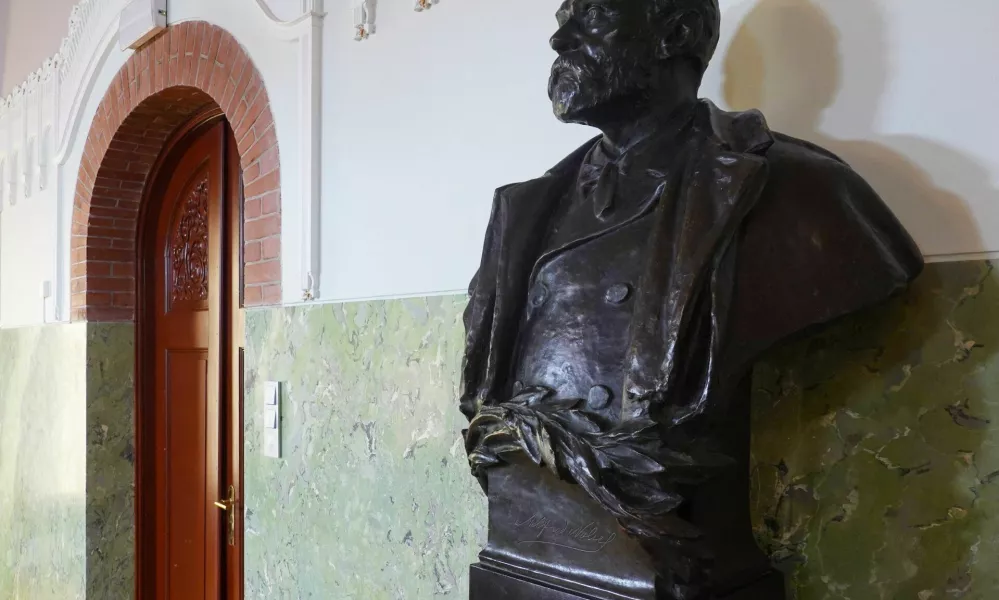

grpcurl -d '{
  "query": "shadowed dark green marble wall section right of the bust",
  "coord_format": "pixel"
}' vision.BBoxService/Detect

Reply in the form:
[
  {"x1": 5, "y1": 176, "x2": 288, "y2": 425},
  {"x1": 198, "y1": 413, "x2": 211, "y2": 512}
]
[{"x1": 753, "y1": 262, "x2": 999, "y2": 600}]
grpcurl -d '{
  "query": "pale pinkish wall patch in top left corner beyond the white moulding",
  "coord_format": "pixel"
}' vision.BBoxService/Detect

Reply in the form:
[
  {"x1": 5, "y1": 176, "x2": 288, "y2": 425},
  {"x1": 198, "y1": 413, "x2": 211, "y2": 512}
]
[{"x1": 0, "y1": 0, "x2": 76, "y2": 96}]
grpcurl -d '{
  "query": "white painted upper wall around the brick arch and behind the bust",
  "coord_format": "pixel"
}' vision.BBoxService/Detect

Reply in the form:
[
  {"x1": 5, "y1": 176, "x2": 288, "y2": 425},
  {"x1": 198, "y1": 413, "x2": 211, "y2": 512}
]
[{"x1": 0, "y1": 0, "x2": 999, "y2": 325}]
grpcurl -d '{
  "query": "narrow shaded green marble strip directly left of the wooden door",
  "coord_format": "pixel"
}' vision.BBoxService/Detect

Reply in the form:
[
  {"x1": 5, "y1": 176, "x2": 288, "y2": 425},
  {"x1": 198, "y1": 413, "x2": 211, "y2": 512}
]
[{"x1": 86, "y1": 323, "x2": 135, "y2": 600}]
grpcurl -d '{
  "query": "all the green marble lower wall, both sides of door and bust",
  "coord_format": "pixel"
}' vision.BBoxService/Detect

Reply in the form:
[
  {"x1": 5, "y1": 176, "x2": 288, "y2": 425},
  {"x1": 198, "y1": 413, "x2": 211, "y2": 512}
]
[{"x1": 0, "y1": 262, "x2": 999, "y2": 600}]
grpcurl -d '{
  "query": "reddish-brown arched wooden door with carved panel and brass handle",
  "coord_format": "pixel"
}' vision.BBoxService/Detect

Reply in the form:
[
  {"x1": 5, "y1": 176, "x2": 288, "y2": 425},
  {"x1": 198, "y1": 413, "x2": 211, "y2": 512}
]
[{"x1": 137, "y1": 118, "x2": 242, "y2": 600}]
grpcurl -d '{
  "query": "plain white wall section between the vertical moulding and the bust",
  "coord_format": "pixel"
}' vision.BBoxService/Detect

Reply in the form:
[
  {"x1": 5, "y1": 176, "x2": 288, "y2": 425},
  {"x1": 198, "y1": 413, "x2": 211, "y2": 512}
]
[{"x1": 321, "y1": 0, "x2": 594, "y2": 300}]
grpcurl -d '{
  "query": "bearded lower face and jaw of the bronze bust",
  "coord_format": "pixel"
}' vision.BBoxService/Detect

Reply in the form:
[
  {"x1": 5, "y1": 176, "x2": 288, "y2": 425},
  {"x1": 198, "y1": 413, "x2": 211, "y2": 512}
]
[{"x1": 548, "y1": 53, "x2": 653, "y2": 124}]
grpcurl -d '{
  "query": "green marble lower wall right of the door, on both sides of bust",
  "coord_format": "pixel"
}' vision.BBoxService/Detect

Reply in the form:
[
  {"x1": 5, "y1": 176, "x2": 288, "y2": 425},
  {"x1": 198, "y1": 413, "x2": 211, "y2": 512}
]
[{"x1": 245, "y1": 262, "x2": 999, "y2": 600}]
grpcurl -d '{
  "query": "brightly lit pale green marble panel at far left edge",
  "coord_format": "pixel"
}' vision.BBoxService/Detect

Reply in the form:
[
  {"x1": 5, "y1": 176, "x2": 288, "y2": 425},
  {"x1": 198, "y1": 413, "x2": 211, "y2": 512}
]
[{"x1": 0, "y1": 325, "x2": 86, "y2": 600}]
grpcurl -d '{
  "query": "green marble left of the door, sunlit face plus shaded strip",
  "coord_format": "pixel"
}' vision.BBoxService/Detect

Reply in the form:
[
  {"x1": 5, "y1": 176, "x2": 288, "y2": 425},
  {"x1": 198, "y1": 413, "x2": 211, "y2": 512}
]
[{"x1": 0, "y1": 323, "x2": 134, "y2": 600}]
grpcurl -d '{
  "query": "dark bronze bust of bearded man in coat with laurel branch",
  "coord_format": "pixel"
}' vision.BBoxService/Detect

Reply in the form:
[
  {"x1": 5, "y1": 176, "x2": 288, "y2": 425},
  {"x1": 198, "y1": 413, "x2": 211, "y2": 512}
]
[{"x1": 460, "y1": 0, "x2": 923, "y2": 600}]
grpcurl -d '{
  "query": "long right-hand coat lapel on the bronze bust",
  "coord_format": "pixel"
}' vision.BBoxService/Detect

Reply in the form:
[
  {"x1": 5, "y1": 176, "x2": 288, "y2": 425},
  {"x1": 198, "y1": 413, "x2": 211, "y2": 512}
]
[{"x1": 622, "y1": 101, "x2": 773, "y2": 419}]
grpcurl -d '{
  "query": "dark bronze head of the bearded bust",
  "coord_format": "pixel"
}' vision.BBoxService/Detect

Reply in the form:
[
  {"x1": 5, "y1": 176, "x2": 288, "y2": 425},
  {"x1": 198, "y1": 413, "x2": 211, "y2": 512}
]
[{"x1": 548, "y1": 0, "x2": 720, "y2": 127}]
